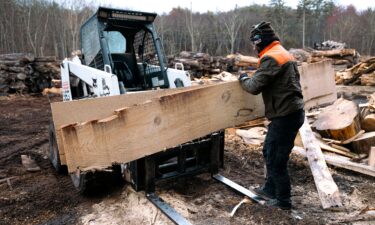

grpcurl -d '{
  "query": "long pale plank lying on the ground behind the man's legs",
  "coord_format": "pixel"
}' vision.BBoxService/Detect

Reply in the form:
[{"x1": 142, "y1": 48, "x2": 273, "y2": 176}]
[{"x1": 299, "y1": 118, "x2": 342, "y2": 209}]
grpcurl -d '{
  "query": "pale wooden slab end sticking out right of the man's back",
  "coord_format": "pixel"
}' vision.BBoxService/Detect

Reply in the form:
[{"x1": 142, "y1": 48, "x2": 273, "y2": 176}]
[{"x1": 298, "y1": 60, "x2": 337, "y2": 109}]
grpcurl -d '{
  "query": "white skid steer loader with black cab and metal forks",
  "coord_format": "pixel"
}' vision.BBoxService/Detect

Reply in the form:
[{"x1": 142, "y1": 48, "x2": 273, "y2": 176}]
[{"x1": 49, "y1": 7, "x2": 266, "y2": 224}]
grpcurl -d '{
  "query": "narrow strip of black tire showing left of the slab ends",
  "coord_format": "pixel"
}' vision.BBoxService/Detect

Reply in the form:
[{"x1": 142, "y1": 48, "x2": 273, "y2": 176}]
[{"x1": 49, "y1": 121, "x2": 67, "y2": 174}]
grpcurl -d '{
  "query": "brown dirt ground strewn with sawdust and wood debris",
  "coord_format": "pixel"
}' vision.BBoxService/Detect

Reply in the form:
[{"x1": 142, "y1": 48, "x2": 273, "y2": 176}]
[{"x1": 0, "y1": 96, "x2": 375, "y2": 224}]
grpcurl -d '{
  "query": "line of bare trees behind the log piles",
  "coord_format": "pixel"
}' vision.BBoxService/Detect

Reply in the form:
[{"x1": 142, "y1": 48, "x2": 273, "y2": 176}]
[{"x1": 0, "y1": 0, "x2": 375, "y2": 59}]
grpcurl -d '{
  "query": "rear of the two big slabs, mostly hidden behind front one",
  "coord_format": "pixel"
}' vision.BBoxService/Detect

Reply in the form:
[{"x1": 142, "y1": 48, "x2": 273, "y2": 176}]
[{"x1": 51, "y1": 62, "x2": 336, "y2": 168}]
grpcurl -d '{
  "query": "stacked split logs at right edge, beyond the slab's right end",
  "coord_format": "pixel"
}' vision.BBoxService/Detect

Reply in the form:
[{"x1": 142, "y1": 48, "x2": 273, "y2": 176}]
[{"x1": 336, "y1": 57, "x2": 375, "y2": 86}]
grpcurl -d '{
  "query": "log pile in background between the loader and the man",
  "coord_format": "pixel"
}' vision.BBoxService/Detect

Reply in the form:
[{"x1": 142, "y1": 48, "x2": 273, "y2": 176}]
[{"x1": 168, "y1": 51, "x2": 258, "y2": 78}]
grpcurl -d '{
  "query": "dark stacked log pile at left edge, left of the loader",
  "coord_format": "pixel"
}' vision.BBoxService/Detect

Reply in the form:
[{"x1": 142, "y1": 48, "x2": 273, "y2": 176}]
[{"x1": 0, "y1": 53, "x2": 60, "y2": 94}]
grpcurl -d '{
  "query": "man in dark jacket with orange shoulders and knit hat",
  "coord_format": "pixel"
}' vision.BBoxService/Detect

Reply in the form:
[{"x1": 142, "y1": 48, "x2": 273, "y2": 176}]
[{"x1": 239, "y1": 22, "x2": 305, "y2": 209}]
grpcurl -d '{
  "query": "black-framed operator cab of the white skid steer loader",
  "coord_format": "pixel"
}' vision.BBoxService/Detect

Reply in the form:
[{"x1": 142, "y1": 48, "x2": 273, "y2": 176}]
[{"x1": 80, "y1": 7, "x2": 169, "y2": 91}]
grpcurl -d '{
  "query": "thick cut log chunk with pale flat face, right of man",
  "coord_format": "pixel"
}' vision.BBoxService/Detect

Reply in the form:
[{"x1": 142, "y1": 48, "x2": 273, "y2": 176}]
[{"x1": 312, "y1": 98, "x2": 361, "y2": 141}]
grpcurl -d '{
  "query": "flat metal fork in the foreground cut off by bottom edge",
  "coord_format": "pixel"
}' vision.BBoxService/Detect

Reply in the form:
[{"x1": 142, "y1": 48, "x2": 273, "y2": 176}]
[{"x1": 146, "y1": 192, "x2": 192, "y2": 225}]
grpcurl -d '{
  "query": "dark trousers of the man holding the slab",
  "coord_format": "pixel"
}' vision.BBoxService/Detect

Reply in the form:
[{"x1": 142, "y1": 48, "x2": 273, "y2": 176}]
[{"x1": 263, "y1": 109, "x2": 305, "y2": 203}]
